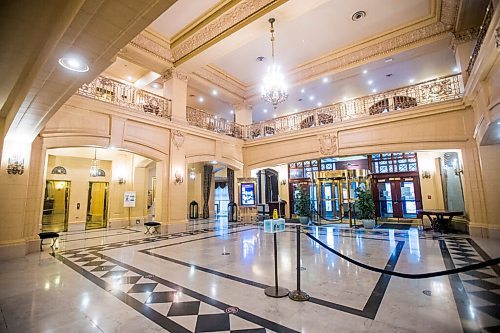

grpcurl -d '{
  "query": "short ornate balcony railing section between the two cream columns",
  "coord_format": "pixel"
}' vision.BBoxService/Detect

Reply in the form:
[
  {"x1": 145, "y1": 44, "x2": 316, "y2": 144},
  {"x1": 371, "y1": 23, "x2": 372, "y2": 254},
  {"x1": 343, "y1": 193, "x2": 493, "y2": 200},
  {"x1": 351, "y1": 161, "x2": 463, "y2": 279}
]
[{"x1": 186, "y1": 106, "x2": 243, "y2": 139}]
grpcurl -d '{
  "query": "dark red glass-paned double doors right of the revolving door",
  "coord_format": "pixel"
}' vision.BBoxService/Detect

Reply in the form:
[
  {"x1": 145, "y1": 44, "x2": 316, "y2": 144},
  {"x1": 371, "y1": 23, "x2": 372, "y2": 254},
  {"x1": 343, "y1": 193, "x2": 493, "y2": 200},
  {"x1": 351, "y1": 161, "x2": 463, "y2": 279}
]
[{"x1": 374, "y1": 176, "x2": 422, "y2": 218}]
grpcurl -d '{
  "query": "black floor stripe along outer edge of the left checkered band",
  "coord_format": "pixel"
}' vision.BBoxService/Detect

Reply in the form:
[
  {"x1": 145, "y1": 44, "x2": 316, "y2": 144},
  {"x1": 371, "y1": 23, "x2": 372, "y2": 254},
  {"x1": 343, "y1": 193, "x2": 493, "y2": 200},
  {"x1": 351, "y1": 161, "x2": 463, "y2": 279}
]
[{"x1": 55, "y1": 254, "x2": 191, "y2": 333}]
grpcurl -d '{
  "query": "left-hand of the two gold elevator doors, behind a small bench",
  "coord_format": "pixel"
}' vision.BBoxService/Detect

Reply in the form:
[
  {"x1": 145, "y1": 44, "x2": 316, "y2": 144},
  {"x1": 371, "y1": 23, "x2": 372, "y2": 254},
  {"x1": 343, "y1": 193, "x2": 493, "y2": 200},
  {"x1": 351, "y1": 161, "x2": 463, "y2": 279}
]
[{"x1": 42, "y1": 180, "x2": 71, "y2": 232}]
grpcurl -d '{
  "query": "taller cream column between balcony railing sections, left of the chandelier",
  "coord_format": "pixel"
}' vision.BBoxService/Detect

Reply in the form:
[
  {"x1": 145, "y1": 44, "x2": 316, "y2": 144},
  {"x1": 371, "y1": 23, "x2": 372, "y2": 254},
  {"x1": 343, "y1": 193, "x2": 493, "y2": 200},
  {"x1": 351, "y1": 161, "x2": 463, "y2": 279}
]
[{"x1": 163, "y1": 68, "x2": 189, "y2": 123}]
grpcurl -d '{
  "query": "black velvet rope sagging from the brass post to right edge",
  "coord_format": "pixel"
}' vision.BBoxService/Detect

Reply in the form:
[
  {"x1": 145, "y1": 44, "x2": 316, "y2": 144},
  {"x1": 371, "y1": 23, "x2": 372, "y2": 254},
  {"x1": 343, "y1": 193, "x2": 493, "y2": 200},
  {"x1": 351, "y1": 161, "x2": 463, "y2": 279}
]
[{"x1": 305, "y1": 232, "x2": 500, "y2": 279}]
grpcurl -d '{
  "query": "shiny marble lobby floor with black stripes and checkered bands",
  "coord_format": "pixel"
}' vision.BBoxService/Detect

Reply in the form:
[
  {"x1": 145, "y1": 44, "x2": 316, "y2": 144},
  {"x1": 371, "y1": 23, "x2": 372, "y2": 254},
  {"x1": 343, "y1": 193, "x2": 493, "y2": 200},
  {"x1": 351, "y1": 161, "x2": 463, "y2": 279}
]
[{"x1": 0, "y1": 220, "x2": 500, "y2": 333}]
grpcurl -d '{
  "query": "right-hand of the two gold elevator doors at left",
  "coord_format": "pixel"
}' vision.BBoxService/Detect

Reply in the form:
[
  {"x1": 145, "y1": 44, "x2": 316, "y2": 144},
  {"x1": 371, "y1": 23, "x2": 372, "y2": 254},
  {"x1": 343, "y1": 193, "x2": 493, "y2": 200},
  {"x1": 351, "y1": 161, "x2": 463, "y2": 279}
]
[{"x1": 85, "y1": 182, "x2": 109, "y2": 230}]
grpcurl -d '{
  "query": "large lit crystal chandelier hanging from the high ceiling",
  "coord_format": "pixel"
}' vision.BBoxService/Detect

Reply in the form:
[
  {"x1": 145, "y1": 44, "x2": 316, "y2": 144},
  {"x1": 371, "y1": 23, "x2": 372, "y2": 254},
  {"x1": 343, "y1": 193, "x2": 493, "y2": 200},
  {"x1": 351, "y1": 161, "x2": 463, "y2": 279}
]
[{"x1": 262, "y1": 18, "x2": 288, "y2": 109}]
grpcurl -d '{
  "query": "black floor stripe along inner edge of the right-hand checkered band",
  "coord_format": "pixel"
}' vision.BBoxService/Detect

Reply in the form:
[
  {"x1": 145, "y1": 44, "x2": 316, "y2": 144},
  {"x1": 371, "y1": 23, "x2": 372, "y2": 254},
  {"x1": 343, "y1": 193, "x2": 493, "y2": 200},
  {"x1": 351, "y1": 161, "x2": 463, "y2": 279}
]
[{"x1": 439, "y1": 240, "x2": 481, "y2": 333}]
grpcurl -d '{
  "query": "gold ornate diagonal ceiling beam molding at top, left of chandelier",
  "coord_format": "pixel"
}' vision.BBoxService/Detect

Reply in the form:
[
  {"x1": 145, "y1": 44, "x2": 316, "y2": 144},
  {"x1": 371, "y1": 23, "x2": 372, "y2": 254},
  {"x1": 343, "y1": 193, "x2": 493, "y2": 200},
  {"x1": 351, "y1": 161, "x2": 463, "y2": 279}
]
[{"x1": 172, "y1": 0, "x2": 287, "y2": 64}]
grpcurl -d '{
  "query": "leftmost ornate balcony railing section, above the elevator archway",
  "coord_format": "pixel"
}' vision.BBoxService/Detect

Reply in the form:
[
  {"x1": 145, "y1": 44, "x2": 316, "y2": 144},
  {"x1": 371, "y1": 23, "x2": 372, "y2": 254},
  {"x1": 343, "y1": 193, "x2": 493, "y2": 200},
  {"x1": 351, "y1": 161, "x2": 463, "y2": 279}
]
[{"x1": 77, "y1": 76, "x2": 172, "y2": 119}]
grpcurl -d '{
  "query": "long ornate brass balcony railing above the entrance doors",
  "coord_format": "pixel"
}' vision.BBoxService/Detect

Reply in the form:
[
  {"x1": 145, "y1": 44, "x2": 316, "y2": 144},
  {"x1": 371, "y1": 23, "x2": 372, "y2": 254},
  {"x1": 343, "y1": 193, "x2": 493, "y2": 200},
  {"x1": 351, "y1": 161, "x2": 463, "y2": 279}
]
[{"x1": 243, "y1": 74, "x2": 463, "y2": 140}]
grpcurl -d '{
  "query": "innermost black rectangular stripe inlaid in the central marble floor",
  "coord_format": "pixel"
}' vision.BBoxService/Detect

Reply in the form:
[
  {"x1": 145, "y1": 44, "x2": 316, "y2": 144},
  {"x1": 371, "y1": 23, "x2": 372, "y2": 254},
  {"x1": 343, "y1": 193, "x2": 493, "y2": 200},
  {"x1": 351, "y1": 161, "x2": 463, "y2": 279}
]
[{"x1": 138, "y1": 228, "x2": 405, "y2": 319}]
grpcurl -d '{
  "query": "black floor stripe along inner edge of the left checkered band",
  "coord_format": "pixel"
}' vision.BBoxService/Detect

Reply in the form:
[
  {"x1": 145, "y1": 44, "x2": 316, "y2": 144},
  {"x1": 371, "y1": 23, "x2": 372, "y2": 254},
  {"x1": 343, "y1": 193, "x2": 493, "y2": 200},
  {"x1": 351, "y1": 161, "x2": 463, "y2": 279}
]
[{"x1": 93, "y1": 252, "x2": 299, "y2": 333}]
